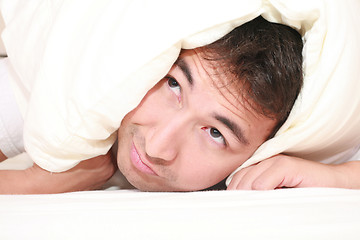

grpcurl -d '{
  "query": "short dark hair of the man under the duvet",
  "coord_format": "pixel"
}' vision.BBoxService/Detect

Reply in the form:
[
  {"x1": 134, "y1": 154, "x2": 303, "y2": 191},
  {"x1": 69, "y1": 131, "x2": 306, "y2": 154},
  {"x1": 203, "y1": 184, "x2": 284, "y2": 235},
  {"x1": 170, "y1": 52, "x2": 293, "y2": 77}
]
[{"x1": 203, "y1": 16, "x2": 303, "y2": 137}]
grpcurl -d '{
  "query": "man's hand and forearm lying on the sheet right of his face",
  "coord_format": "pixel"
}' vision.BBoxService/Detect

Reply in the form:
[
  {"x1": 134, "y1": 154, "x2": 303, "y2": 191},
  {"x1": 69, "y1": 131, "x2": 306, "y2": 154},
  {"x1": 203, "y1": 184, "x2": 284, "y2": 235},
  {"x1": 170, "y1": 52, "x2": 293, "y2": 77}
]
[{"x1": 227, "y1": 154, "x2": 360, "y2": 190}]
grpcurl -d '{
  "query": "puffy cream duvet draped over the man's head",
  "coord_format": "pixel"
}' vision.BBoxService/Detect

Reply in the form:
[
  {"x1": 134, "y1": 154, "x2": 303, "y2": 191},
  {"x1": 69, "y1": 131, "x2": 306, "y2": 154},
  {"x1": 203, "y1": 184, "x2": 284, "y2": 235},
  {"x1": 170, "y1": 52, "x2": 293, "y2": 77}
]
[{"x1": 1, "y1": 0, "x2": 360, "y2": 188}]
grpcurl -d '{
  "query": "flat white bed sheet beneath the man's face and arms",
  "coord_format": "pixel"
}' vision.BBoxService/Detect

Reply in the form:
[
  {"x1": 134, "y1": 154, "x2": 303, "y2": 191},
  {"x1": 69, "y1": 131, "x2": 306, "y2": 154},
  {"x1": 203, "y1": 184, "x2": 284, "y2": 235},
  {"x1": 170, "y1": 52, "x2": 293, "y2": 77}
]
[{"x1": 0, "y1": 188, "x2": 360, "y2": 240}]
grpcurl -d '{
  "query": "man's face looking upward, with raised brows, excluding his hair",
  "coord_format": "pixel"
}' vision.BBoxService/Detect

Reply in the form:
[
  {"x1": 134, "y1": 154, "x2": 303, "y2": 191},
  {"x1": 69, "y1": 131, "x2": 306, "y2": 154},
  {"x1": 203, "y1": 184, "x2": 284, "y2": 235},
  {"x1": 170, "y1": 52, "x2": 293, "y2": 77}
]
[{"x1": 117, "y1": 50, "x2": 276, "y2": 191}]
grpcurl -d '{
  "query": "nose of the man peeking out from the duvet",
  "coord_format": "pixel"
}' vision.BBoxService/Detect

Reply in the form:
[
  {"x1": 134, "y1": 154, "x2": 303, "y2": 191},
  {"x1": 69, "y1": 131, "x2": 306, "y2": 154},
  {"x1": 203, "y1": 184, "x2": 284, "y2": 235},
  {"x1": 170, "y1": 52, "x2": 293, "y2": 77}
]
[{"x1": 145, "y1": 113, "x2": 189, "y2": 161}]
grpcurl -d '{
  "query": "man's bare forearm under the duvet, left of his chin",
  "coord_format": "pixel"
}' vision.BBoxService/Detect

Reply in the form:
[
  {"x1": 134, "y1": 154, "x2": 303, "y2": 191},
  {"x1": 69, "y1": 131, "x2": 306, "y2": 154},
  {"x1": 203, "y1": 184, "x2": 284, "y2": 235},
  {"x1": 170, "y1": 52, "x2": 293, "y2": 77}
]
[{"x1": 0, "y1": 153, "x2": 117, "y2": 194}]
